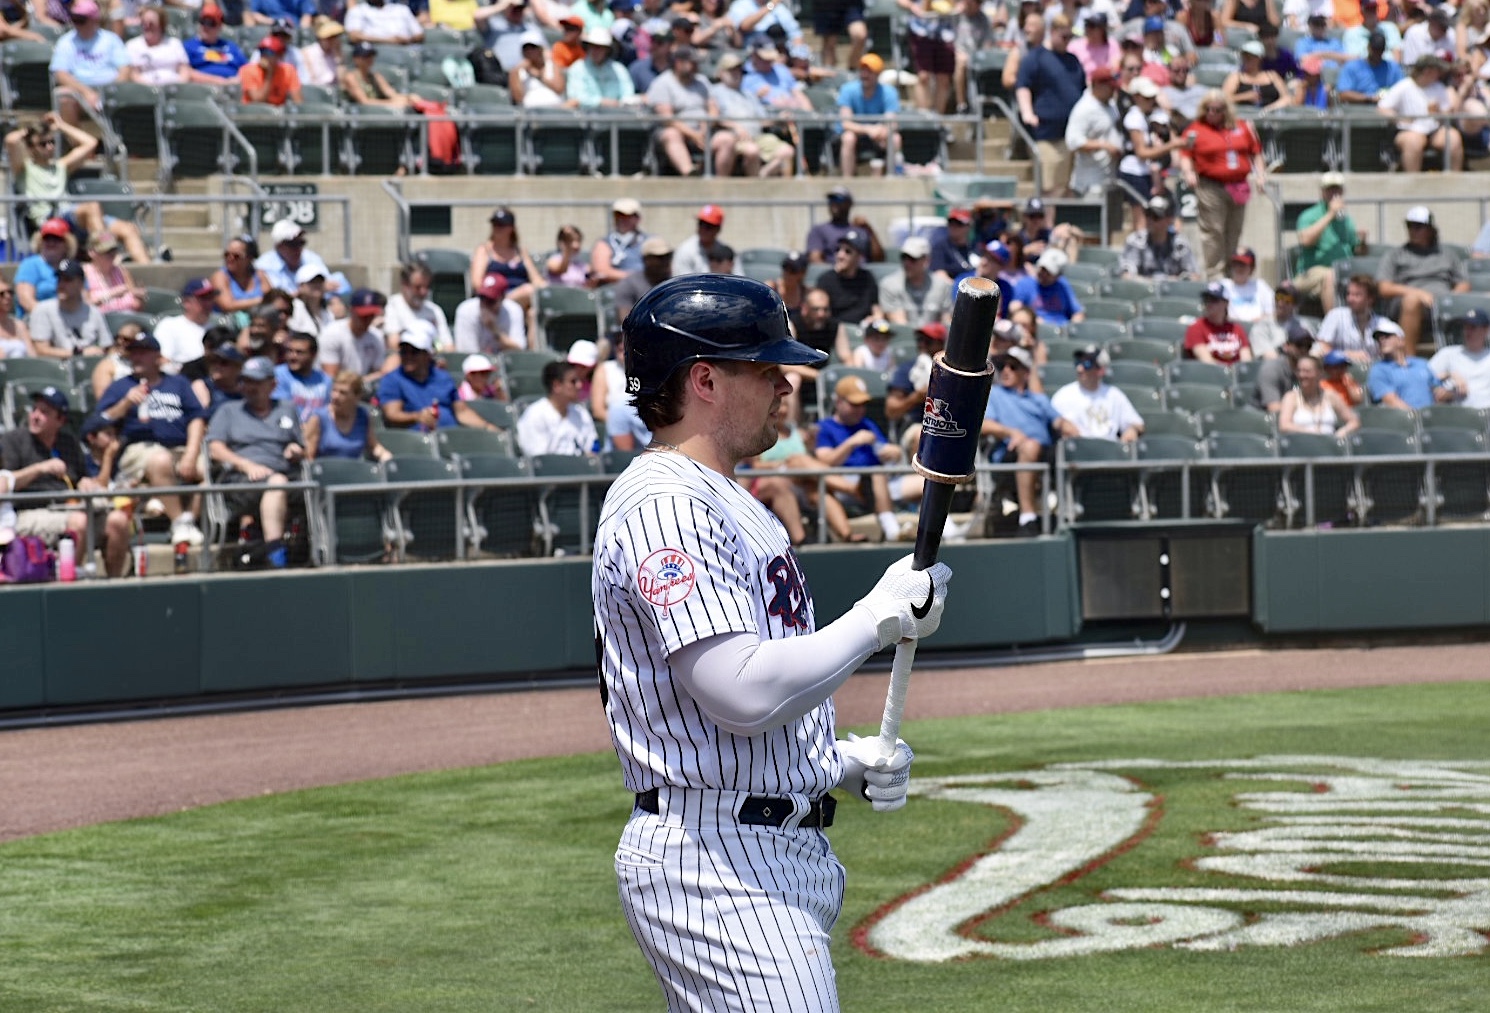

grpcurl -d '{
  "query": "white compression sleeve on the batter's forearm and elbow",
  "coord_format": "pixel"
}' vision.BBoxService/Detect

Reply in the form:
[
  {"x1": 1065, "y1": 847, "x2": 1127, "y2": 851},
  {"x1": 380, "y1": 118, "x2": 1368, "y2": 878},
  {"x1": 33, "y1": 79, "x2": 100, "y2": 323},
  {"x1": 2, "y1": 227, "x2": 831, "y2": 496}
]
[{"x1": 668, "y1": 608, "x2": 879, "y2": 734}]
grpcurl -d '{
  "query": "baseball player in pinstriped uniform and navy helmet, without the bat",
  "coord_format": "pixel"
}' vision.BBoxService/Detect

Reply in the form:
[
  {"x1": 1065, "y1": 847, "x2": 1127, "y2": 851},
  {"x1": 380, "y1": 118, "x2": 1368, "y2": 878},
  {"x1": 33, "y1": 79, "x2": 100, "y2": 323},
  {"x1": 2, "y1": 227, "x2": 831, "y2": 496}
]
[{"x1": 593, "y1": 274, "x2": 951, "y2": 1013}]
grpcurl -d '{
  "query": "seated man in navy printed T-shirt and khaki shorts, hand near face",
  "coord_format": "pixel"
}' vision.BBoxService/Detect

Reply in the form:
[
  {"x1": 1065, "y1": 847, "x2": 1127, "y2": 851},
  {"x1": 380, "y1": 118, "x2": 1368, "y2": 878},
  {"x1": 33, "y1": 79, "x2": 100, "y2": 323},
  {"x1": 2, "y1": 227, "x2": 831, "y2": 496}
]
[{"x1": 98, "y1": 334, "x2": 207, "y2": 545}]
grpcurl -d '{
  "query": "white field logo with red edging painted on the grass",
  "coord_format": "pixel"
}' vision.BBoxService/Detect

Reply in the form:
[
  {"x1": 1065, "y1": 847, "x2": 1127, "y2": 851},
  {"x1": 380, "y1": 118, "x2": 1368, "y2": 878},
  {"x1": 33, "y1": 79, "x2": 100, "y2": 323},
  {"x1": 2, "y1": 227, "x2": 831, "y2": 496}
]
[{"x1": 854, "y1": 755, "x2": 1490, "y2": 962}]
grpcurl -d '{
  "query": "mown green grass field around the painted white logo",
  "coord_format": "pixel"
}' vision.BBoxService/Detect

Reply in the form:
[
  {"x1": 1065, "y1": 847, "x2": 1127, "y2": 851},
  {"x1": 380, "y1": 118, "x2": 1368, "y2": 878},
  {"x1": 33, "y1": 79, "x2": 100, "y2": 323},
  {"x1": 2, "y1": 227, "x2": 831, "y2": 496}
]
[{"x1": 0, "y1": 684, "x2": 1490, "y2": 1013}]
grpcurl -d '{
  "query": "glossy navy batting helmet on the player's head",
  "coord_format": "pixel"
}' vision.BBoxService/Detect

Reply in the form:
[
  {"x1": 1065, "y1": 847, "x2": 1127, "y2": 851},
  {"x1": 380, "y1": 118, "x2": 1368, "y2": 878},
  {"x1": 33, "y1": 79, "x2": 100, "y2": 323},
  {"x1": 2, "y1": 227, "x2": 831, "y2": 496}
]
[{"x1": 621, "y1": 274, "x2": 827, "y2": 393}]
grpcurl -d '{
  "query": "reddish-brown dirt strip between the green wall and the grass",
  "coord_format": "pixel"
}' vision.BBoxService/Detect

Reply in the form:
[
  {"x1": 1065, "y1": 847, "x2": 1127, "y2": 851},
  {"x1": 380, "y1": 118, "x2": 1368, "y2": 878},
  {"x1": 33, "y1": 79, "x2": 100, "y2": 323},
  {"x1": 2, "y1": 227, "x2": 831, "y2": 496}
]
[{"x1": 0, "y1": 645, "x2": 1490, "y2": 840}]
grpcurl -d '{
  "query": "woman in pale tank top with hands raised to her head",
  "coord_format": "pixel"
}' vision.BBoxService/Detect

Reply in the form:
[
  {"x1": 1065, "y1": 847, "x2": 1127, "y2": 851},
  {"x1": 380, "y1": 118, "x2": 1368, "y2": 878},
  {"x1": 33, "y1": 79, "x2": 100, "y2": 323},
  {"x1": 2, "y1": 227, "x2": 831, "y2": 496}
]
[{"x1": 4, "y1": 113, "x2": 150, "y2": 266}]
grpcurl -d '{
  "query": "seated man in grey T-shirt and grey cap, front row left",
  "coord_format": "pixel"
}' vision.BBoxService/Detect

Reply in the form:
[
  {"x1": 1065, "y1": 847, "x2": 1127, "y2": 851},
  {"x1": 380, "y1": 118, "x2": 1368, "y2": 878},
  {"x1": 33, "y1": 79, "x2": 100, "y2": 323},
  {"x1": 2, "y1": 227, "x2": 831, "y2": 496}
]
[{"x1": 207, "y1": 358, "x2": 305, "y2": 569}]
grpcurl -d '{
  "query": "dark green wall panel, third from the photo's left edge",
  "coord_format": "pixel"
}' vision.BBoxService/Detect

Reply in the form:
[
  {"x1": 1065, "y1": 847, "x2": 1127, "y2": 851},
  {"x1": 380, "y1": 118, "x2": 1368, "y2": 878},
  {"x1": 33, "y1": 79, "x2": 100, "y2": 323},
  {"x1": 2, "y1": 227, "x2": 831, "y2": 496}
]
[{"x1": 201, "y1": 572, "x2": 352, "y2": 693}]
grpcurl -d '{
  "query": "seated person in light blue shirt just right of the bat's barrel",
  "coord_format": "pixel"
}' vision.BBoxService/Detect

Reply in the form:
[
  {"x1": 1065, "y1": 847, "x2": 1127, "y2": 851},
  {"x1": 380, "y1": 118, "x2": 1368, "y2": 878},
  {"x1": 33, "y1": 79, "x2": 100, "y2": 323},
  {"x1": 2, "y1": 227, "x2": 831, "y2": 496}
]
[{"x1": 982, "y1": 346, "x2": 1080, "y2": 536}]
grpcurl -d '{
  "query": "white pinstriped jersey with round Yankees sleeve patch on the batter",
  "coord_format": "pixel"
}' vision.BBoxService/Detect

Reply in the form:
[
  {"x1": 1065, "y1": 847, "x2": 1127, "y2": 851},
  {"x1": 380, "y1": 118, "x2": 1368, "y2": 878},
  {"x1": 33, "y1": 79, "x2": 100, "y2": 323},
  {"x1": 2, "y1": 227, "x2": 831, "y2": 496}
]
[{"x1": 592, "y1": 451, "x2": 842, "y2": 797}]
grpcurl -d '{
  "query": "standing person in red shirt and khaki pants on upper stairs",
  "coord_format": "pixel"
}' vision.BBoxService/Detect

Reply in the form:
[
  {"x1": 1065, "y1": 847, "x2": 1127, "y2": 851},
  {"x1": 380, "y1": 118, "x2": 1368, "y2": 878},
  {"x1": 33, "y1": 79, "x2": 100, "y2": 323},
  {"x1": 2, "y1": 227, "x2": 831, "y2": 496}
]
[{"x1": 1177, "y1": 91, "x2": 1267, "y2": 280}]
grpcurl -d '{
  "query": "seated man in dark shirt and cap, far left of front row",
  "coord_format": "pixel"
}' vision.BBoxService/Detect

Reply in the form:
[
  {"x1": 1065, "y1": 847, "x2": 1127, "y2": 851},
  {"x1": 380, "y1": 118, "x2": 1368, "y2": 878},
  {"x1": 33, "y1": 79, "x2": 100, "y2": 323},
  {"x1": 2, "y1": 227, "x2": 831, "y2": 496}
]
[{"x1": 0, "y1": 387, "x2": 130, "y2": 577}]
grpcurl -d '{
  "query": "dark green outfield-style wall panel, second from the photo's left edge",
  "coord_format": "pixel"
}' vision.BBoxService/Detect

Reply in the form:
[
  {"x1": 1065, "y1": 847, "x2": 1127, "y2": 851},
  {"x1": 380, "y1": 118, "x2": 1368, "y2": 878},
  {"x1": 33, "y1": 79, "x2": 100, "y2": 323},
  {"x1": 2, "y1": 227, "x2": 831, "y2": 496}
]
[{"x1": 43, "y1": 579, "x2": 201, "y2": 705}]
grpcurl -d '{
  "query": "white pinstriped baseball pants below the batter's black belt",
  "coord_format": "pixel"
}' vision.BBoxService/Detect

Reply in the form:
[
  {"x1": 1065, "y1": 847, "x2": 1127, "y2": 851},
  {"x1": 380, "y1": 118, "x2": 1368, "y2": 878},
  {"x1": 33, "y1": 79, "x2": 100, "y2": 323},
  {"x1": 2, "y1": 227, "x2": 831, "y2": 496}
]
[{"x1": 615, "y1": 810, "x2": 843, "y2": 1013}]
